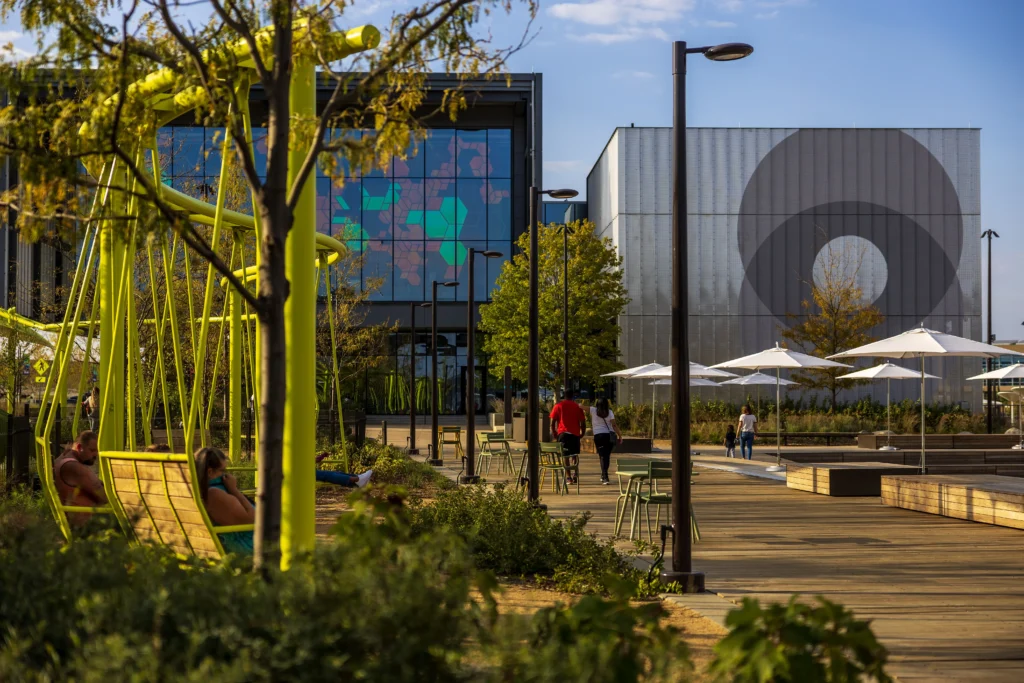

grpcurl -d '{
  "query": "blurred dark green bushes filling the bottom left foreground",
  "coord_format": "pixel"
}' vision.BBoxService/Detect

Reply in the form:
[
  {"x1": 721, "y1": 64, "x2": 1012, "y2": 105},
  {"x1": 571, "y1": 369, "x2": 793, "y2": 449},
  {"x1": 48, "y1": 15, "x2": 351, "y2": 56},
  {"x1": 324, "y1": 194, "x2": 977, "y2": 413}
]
[{"x1": 0, "y1": 492, "x2": 700, "y2": 683}]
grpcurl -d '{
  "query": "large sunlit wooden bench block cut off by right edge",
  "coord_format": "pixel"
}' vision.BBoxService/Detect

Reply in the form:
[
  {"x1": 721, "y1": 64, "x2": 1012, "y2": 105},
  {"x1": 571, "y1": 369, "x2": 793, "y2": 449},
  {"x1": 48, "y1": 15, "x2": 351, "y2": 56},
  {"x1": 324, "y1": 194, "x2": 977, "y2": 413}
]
[{"x1": 882, "y1": 474, "x2": 1024, "y2": 528}]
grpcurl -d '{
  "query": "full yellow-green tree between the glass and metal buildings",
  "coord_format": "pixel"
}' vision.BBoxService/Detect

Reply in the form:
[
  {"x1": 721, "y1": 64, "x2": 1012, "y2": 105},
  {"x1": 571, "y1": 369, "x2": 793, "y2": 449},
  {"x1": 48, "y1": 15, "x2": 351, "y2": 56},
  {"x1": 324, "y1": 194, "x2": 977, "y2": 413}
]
[{"x1": 479, "y1": 220, "x2": 630, "y2": 389}]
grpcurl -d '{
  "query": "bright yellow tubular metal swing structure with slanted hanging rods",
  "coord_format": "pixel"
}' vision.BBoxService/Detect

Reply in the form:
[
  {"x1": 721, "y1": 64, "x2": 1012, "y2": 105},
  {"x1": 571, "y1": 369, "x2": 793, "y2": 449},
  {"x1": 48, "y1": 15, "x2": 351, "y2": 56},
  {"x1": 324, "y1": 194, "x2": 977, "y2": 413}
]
[{"x1": 35, "y1": 26, "x2": 380, "y2": 566}]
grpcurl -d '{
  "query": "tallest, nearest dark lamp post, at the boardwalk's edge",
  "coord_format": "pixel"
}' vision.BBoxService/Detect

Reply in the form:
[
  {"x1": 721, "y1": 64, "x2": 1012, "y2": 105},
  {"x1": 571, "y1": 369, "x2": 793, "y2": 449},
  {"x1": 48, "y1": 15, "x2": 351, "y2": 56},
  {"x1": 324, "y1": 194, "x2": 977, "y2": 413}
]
[{"x1": 662, "y1": 41, "x2": 754, "y2": 593}]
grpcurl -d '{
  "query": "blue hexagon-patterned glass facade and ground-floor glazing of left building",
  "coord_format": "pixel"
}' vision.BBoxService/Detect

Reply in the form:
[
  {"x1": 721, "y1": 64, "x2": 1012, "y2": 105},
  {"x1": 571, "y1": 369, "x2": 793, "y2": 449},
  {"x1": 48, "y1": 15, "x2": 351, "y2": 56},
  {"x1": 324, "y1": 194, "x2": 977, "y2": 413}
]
[{"x1": 159, "y1": 126, "x2": 513, "y2": 415}]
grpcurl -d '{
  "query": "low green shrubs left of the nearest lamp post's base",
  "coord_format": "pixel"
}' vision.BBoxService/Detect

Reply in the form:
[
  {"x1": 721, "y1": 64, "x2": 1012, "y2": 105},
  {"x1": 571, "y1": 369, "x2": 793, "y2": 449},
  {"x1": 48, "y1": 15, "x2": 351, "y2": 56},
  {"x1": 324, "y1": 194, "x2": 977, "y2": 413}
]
[{"x1": 413, "y1": 485, "x2": 665, "y2": 597}]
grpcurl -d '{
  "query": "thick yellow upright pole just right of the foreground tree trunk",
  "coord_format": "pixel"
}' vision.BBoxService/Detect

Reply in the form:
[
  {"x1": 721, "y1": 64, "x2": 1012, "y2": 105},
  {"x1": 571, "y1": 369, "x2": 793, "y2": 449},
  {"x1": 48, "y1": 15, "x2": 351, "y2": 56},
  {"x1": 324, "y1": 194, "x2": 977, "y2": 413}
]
[{"x1": 281, "y1": 61, "x2": 316, "y2": 568}]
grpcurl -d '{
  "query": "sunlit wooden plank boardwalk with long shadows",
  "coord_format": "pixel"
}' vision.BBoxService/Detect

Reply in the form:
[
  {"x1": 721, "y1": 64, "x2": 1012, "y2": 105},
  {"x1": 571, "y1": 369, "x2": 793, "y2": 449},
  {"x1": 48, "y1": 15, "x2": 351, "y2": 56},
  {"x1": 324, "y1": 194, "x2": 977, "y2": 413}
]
[{"x1": 445, "y1": 454, "x2": 1024, "y2": 681}]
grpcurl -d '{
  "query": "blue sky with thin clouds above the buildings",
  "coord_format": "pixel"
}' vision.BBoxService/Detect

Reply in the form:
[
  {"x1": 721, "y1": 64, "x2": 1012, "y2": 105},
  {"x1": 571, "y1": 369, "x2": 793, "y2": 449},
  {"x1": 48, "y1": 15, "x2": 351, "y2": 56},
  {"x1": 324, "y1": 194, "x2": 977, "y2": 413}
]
[{"x1": 0, "y1": 0, "x2": 1024, "y2": 339}]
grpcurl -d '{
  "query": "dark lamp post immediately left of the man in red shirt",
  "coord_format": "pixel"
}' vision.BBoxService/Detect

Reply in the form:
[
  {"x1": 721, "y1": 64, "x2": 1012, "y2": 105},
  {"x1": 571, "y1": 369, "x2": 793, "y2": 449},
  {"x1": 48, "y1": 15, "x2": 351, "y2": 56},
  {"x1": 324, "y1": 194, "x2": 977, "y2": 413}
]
[{"x1": 526, "y1": 185, "x2": 580, "y2": 504}]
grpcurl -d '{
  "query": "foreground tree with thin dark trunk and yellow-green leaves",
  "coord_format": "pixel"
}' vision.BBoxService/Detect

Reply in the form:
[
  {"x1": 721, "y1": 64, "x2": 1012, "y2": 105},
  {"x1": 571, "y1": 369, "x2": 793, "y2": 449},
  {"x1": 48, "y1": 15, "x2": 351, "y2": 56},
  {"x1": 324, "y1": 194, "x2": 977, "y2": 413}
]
[{"x1": 0, "y1": 0, "x2": 537, "y2": 567}]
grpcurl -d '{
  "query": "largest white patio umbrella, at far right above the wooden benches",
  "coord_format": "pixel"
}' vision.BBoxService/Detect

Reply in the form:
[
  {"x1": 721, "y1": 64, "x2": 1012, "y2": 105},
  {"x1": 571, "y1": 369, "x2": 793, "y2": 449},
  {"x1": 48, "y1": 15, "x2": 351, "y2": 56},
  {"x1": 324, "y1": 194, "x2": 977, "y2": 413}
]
[{"x1": 830, "y1": 327, "x2": 1024, "y2": 474}]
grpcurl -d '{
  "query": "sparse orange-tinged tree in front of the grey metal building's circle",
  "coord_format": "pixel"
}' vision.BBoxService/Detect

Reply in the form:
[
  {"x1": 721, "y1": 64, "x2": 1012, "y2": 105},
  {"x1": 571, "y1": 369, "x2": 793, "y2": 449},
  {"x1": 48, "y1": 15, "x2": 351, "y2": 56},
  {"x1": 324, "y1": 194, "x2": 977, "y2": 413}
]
[{"x1": 779, "y1": 235, "x2": 885, "y2": 413}]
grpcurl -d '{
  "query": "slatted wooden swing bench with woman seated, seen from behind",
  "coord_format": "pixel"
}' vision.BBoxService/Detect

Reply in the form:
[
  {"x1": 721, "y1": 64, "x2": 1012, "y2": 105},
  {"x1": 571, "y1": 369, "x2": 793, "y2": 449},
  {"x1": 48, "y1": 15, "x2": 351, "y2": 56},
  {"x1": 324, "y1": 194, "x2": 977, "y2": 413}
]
[{"x1": 99, "y1": 452, "x2": 253, "y2": 559}]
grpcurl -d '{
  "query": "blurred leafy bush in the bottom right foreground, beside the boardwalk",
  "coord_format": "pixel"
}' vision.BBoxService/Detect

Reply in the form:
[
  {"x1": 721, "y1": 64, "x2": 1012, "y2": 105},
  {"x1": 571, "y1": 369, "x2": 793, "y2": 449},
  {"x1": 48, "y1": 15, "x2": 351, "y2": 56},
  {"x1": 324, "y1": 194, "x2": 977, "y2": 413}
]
[{"x1": 709, "y1": 596, "x2": 892, "y2": 683}]
